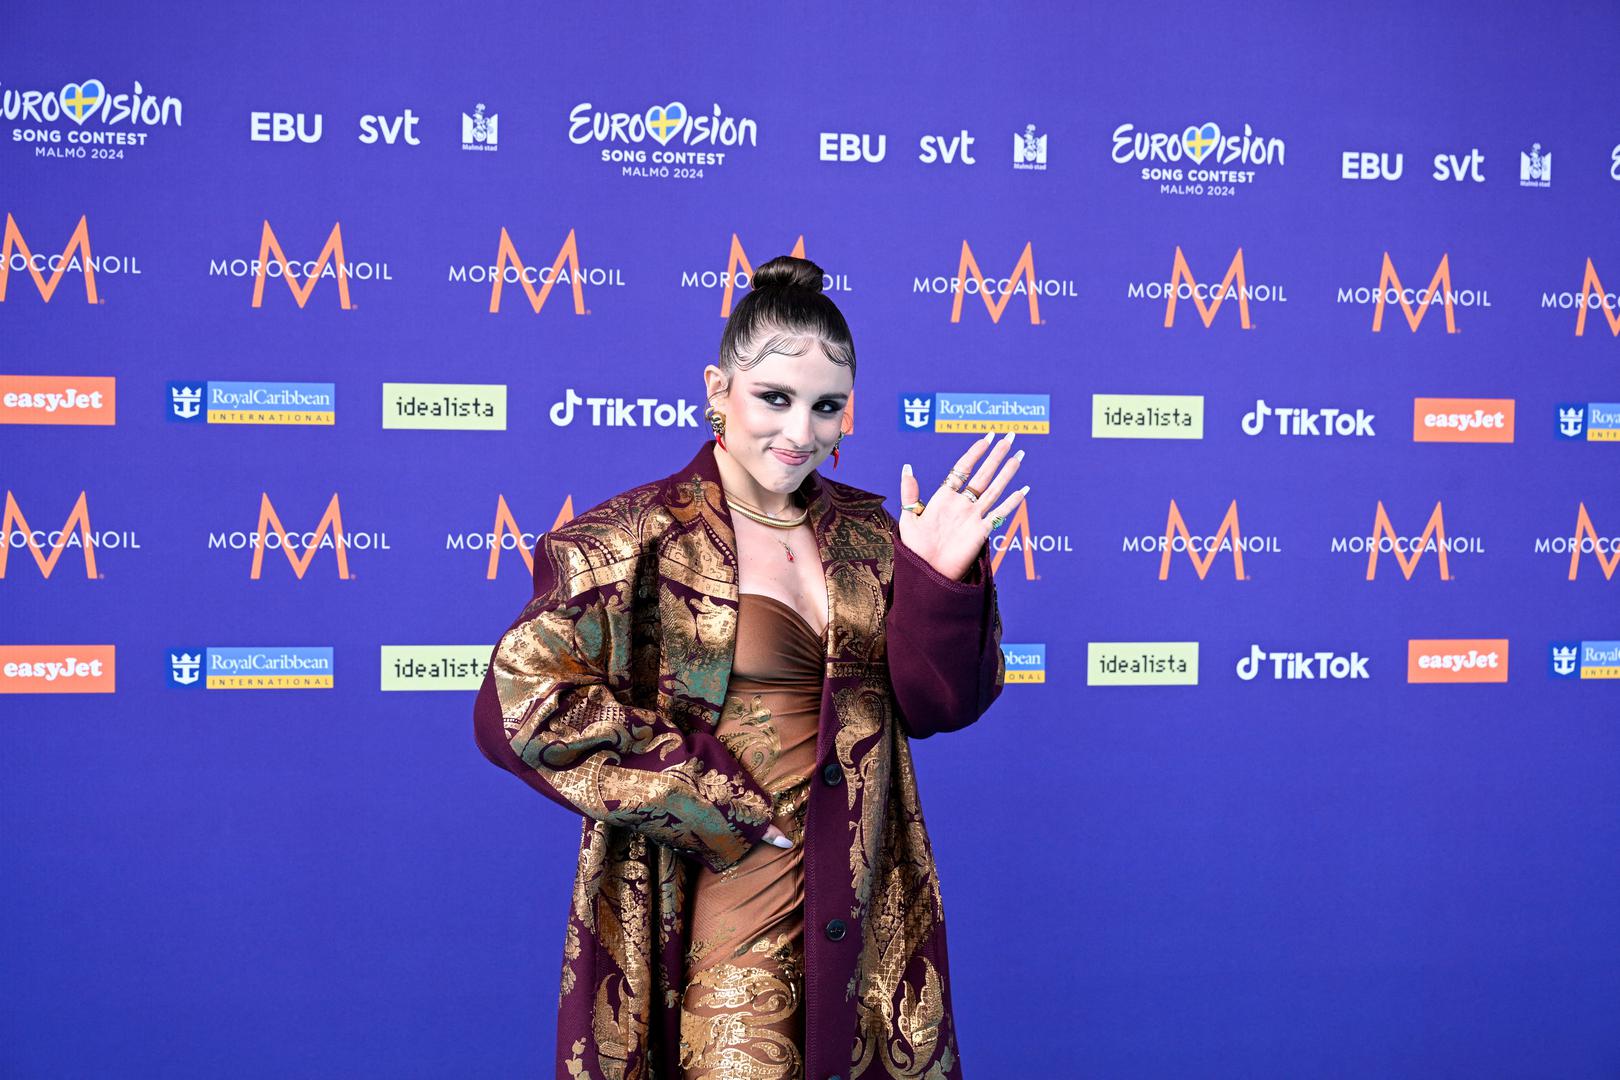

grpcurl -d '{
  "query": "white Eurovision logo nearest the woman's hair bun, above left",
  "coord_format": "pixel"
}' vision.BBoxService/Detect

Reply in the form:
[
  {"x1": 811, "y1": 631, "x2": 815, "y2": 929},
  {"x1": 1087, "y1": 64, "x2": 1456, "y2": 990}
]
[{"x1": 569, "y1": 102, "x2": 760, "y2": 180}]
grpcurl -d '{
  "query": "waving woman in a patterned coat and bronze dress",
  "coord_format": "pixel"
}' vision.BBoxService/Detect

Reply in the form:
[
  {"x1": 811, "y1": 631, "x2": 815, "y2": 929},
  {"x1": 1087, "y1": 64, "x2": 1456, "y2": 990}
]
[{"x1": 475, "y1": 256, "x2": 1029, "y2": 1080}]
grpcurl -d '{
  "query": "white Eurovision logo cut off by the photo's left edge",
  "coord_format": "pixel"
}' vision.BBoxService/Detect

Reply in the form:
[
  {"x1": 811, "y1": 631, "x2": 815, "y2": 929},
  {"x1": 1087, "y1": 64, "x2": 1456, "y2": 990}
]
[{"x1": 0, "y1": 79, "x2": 185, "y2": 160}]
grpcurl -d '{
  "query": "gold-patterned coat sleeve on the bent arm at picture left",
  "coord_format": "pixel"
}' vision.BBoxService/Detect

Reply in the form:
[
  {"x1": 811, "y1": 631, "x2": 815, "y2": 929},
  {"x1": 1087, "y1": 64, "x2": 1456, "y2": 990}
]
[{"x1": 473, "y1": 534, "x2": 771, "y2": 871}]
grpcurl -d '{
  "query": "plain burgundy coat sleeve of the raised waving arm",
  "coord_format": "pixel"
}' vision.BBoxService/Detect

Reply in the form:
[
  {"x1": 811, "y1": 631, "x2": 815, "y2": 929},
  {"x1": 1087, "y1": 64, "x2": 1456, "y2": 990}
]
[{"x1": 885, "y1": 529, "x2": 1006, "y2": 738}]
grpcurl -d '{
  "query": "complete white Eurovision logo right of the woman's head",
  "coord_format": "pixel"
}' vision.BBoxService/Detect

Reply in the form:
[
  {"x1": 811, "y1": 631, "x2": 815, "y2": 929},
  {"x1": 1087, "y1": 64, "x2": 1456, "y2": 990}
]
[{"x1": 1113, "y1": 121, "x2": 1288, "y2": 196}]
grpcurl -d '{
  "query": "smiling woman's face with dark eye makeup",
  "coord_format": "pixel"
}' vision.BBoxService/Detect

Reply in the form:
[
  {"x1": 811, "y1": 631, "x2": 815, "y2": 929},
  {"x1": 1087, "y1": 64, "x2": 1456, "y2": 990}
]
[{"x1": 703, "y1": 340, "x2": 855, "y2": 494}]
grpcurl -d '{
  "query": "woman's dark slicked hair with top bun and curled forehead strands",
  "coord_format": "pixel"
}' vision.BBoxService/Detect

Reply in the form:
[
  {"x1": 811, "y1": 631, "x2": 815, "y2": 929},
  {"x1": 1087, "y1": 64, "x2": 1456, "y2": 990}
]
[{"x1": 716, "y1": 254, "x2": 855, "y2": 376}]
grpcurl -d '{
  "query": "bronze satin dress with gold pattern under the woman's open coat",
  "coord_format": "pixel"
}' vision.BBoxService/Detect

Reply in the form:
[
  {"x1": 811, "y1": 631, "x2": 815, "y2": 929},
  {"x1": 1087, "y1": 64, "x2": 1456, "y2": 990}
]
[{"x1": 680, "y1": 593, "x2": 826, "y2": 1080}]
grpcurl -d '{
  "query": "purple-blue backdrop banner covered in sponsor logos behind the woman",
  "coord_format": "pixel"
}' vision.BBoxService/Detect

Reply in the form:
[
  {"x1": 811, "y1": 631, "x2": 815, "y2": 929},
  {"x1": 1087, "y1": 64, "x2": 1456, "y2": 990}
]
[{"x1": 0, "y1": 3, "x2": 1620, "y2": 1077}]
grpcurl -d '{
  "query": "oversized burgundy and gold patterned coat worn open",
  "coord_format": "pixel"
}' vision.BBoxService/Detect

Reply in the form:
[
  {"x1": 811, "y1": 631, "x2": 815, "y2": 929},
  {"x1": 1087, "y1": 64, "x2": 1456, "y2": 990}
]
[{"x1": 475, "y1": 444, "x2": 1003, "y2": 1080}]
